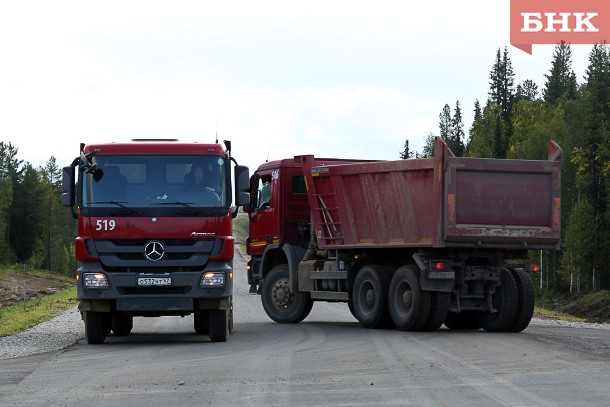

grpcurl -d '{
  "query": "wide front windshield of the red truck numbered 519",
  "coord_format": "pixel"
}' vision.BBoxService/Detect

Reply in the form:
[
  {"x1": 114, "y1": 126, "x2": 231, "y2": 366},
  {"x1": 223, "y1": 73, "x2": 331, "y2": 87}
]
[{"x1": 82, "y1": 155, "x2": 229, "y2": 208}]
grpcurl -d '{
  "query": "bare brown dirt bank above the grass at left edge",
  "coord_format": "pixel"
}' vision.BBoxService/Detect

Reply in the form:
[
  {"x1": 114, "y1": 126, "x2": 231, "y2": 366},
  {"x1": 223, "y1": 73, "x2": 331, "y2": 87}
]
[{"x1": 0, "y1": 272, "x2": 71, "y2": 307}]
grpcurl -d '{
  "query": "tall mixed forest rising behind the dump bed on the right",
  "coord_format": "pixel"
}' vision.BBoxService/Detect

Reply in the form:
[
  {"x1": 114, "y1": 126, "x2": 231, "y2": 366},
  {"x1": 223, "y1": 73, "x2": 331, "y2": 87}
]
[{"x1": 400, "y1": 43, "x2": 610, "y2": 293}]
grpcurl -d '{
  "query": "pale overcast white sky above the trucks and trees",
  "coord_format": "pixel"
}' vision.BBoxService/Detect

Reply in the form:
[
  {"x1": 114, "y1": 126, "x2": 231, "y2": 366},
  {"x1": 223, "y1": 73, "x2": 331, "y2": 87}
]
[{"x1": 0, "y1": 0, "x2": 591, "y2": 173}]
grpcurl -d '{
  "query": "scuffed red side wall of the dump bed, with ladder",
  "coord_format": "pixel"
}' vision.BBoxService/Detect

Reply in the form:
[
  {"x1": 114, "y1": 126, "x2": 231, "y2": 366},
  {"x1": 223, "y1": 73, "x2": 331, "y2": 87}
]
[{"x1": 304, "y1": 159, "x2": 440, "y2": 247}]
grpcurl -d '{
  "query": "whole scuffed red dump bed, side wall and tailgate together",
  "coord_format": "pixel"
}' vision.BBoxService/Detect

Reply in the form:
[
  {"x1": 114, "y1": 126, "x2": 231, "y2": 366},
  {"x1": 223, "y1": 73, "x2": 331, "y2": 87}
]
[{"x1": 302, "y1": 138, "x2": 561, "y2": 252}]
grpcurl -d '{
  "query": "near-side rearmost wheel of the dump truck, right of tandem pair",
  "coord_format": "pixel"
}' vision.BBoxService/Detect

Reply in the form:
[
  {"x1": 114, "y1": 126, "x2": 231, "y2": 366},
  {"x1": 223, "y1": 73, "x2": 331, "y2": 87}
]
[{"x1": 388, "y1": 266, "x2": 432, "y2": 331}]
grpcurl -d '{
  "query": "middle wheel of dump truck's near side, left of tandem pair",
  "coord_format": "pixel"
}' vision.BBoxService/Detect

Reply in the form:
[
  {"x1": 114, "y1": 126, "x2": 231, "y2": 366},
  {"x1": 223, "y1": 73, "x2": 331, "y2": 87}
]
[{"x1": 352, "y1": 265, "x2": 392, "y2": 328}]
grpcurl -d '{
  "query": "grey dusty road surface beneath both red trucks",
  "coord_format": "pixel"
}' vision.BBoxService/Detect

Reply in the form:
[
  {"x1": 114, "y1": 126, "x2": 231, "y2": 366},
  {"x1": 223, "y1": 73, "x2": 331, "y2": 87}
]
[{"x1": 0, "y1": 250, "x2": 610, "y2": 407}]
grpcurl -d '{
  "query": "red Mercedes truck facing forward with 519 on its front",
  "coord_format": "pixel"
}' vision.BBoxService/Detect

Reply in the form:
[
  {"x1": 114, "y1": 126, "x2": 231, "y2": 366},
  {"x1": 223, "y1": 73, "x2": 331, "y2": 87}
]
[{"x1": 62, "y1": 140, "x2": 249, "y2": 343}]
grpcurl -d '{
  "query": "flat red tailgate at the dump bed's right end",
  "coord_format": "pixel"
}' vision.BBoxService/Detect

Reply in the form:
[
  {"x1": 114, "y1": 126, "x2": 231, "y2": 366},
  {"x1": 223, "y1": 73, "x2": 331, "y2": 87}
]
[{"x1": 444, "y1": 150, "x2": 561, "y2": 248}]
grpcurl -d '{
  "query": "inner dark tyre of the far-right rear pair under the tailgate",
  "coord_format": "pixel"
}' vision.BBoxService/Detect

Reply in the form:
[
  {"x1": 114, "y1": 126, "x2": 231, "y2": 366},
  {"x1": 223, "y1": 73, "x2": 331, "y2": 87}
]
[{"x1": 480, "y1": 268, "x2": 518, "y2": 332}]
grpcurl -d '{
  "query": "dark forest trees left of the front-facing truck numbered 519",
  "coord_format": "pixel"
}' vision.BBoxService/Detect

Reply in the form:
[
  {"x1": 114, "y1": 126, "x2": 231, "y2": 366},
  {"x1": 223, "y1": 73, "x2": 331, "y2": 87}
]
[{"x1": 0, "y1": 151, "x2": 76, "y2": 276}]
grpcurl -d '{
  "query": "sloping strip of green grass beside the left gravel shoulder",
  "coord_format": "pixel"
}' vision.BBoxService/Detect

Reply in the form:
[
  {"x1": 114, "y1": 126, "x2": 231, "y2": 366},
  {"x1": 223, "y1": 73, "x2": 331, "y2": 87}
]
[{"x1": 0, "y1": 287, "x2": 77, "y2": 337}]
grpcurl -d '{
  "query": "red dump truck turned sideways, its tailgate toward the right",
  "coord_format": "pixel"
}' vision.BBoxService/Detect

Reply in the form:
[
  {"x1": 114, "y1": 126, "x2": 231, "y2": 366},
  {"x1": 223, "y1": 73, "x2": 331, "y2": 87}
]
[{"x1": 246, "y1": 138, "x2": 562, "y2": 332}]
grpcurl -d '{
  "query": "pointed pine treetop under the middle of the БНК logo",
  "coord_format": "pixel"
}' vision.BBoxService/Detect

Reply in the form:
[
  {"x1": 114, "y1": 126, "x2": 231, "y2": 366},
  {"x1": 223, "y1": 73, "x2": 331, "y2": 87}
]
[{"x1": 542, "y1": 41, "x2": 577, "y2": 105}]
